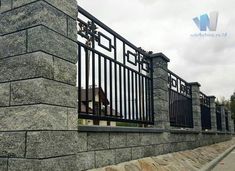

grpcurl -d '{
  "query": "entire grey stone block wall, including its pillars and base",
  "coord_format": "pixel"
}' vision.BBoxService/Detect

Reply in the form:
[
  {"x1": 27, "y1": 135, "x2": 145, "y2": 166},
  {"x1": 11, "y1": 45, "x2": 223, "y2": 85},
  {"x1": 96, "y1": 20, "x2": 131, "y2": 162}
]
[{"x1": 0, "y1": 0, "x2": 234, "y2": 171}]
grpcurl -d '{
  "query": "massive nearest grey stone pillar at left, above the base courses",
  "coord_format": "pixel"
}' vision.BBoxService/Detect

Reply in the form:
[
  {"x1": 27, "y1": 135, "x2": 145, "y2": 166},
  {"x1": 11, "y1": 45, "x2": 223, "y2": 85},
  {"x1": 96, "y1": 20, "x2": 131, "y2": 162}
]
[{"x1": 0, "y1": 0, "x2": 77, "y2": 131}]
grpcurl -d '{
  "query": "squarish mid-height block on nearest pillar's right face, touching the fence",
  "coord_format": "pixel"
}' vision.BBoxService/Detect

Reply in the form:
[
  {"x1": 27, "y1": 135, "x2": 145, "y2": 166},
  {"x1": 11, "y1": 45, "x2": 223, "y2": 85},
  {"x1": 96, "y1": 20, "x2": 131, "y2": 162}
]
[{"x1": 54, "y1": 57, "x2": 77, "y2": 85}]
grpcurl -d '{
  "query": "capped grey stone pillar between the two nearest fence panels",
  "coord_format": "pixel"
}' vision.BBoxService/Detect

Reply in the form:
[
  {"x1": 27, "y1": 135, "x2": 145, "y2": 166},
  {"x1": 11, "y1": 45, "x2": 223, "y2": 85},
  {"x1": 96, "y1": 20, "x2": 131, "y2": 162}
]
[{"x1": 152, "y1": 53, "x2": 170, "y2": 129}]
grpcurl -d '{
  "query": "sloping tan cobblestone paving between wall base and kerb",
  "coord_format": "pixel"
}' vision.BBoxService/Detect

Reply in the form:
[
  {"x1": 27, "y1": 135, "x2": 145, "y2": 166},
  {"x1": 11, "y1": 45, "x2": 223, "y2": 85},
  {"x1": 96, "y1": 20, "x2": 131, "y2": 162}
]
[{"x1": 90, "y1": 139, "x2": 235, "y2": 171}]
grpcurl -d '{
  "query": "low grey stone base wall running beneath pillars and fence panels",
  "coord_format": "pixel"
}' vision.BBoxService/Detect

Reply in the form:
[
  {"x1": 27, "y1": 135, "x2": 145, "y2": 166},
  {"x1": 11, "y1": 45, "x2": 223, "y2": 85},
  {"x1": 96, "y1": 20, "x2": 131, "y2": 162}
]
[{"x1": 0, "y1": 127, "x2": 231, "y2": 171}]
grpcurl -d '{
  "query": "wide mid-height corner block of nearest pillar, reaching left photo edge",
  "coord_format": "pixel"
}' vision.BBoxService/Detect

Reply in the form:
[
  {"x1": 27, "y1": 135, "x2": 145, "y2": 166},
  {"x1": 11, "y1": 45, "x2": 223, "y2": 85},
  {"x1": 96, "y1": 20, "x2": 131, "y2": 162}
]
[{"x1": 0, "y1": 52, "x2": 54, "y2": 82}]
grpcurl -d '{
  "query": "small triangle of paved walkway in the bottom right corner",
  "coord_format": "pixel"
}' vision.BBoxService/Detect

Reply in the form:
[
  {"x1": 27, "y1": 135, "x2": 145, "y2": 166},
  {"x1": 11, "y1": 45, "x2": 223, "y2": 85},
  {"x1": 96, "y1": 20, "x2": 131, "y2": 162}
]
[{"x1": 212, "y1": 150, "x2": 235, "y2": 171}]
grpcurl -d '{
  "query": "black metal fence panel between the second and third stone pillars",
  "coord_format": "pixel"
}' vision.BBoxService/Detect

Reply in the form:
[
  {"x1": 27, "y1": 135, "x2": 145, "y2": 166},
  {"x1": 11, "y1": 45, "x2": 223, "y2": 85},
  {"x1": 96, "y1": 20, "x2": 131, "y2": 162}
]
[{"x1": 168, "y1": 71, "x2": 193, "y2": 128}]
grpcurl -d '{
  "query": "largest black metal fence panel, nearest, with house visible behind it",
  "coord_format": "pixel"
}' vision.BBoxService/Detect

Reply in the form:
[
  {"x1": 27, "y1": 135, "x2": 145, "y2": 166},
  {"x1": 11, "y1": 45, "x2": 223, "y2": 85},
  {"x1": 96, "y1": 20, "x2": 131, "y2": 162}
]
[{"x1": 77, "y1": 7, "x2": 154, "y2": 124}]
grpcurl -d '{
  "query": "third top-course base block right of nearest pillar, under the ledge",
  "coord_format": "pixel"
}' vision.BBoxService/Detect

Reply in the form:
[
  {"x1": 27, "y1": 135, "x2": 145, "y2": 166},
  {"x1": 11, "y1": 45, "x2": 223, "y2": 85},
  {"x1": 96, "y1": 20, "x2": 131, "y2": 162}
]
[{"x1": 110, "y1": 133, "x2": 127, "y2": 148}]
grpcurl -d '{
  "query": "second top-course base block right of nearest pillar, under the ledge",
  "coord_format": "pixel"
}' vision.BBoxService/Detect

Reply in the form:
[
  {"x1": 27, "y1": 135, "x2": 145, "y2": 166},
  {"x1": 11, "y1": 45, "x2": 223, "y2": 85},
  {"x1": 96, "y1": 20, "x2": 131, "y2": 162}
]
[{"x1": 87, "y1": 133, "x2": 109, "y2": 150}]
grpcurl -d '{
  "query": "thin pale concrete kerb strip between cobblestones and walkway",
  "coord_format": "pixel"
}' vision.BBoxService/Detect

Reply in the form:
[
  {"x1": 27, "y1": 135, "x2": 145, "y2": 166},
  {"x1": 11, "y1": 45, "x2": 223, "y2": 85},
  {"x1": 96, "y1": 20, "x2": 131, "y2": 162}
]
[{"x1": 199, "y1": 145, "x2": 235, "y2": 171}]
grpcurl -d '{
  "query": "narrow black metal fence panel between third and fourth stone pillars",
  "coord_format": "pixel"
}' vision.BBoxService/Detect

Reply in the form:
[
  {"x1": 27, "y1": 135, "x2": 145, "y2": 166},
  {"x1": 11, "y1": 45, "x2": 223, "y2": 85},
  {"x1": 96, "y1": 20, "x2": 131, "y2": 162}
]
[{"x1": 200, "y1": 92, "x2": 211, "y2": 130}]
